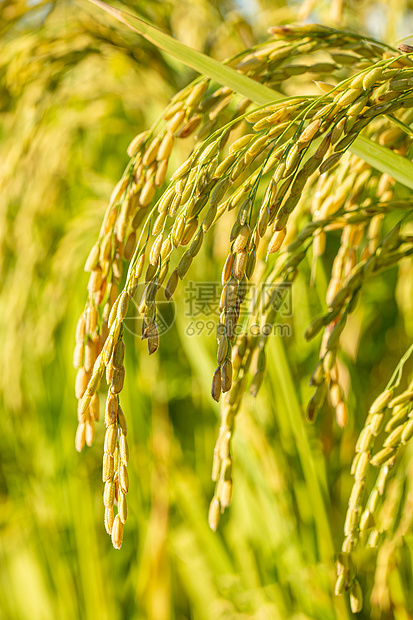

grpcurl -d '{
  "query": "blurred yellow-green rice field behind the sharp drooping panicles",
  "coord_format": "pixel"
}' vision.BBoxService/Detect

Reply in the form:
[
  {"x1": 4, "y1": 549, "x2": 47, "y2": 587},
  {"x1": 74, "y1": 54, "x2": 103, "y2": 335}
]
[{"x1": 0, "y1": 0, "x2": 413, "y2": 620}]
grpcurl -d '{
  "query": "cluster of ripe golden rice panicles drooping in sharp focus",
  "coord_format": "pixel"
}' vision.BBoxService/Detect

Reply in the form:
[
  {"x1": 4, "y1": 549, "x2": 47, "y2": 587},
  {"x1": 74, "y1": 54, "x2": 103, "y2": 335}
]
[{"x1": 74, "y1": 26, "x2": 413, "y2": 588}]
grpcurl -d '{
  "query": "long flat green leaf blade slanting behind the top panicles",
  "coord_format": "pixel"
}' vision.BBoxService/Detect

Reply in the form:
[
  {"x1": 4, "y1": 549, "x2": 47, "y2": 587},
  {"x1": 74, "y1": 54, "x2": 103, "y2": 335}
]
[{"x1": 89, "y1": 0, "x2": 413, "y2": 189}]
